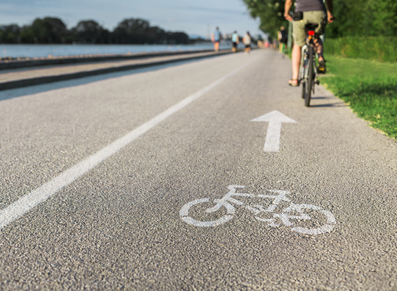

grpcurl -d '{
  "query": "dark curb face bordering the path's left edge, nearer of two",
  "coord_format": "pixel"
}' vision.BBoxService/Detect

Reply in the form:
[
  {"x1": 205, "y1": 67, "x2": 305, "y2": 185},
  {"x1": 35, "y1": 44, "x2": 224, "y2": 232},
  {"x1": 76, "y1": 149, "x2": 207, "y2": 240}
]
[{"x1": 0, "y1": 51, "x2": 232, "y2": 91}]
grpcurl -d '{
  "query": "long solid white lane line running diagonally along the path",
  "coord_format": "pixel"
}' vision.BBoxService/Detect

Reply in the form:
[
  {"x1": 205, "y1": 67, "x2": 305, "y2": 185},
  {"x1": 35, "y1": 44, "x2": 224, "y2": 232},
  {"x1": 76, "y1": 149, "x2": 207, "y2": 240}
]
[{"x1": 0, "y1": 63, "x2": 250, "y2": 229}]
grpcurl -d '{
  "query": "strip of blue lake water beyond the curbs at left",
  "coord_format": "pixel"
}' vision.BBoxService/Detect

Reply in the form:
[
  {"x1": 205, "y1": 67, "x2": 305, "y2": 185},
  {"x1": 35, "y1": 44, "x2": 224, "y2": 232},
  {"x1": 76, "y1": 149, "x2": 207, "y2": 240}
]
[{"x1": 0, "y1": 42, "x2": 238, "y2": 58}]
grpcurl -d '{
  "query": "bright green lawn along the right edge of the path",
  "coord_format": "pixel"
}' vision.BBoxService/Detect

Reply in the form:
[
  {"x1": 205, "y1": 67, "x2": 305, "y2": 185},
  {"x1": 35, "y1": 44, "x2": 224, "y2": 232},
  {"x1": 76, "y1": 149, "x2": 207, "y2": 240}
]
[{"x1": 321, "y1": 56, "x2": 397, "y2": 139}]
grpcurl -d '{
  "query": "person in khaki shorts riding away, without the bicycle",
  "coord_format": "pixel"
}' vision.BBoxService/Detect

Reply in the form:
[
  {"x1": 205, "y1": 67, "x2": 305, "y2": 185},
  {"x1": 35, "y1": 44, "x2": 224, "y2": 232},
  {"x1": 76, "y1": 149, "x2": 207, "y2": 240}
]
[{"x1": 284, "y1": 0, "x2": 334, "y2": 87}]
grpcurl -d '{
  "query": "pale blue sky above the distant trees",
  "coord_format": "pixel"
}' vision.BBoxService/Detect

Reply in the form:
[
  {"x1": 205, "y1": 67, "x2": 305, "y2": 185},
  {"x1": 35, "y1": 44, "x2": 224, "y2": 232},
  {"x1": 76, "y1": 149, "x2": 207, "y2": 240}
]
[{"x1": 0, "y1": 0, "x2": 263, "y2": 37}]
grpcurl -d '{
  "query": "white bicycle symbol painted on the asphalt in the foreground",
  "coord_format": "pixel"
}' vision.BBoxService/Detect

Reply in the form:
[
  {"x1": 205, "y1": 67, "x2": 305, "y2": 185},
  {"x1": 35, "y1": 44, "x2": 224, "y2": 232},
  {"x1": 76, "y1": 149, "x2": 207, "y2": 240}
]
[{"x1": 179, "y1": 185, "x2": 336, "y2": 235}]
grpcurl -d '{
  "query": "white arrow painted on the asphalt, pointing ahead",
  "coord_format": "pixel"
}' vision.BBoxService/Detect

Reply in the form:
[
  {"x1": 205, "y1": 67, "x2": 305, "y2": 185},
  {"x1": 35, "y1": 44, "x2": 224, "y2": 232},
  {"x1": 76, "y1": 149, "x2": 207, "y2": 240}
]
[{"x1": 251, "y1": 110, "x2": 297, "y2": 152}]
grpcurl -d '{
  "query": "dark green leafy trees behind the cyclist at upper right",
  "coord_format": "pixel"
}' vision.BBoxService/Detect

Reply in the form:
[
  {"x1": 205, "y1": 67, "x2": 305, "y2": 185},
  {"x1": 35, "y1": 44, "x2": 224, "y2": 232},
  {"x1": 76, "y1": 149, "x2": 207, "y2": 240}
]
[{"x1": 242, "y1": 0, "x2": 397, "y2": 38}]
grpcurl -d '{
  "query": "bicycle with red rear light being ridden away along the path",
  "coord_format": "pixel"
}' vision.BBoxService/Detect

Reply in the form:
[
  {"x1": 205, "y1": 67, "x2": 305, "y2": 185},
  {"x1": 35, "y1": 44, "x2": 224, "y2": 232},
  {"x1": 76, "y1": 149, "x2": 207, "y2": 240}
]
[{"x1": 300, "y1": 23, "x2": 320, "y2": 107}]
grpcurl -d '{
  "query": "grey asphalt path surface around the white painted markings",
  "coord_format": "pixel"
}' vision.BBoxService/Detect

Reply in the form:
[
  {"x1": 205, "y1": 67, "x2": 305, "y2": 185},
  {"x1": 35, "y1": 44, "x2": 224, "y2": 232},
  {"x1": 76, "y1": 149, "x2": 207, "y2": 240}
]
[{"x1": 0, "y1": 50, "x2": 397, "y2": 290}]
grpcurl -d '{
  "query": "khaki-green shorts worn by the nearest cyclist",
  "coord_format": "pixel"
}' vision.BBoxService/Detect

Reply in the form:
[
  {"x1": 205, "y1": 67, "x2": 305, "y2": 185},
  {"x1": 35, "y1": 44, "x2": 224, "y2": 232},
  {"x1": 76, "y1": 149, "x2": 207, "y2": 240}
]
[{"x1": 293, "y1": 11, "x2": 327, "y2": 47}]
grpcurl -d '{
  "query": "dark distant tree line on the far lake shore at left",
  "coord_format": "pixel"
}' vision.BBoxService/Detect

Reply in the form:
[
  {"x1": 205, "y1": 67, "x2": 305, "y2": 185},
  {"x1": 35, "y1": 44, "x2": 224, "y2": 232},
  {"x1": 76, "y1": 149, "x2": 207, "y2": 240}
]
[{"x1": 0, "y1": 17, "x2": 193, "y2": 44}]
